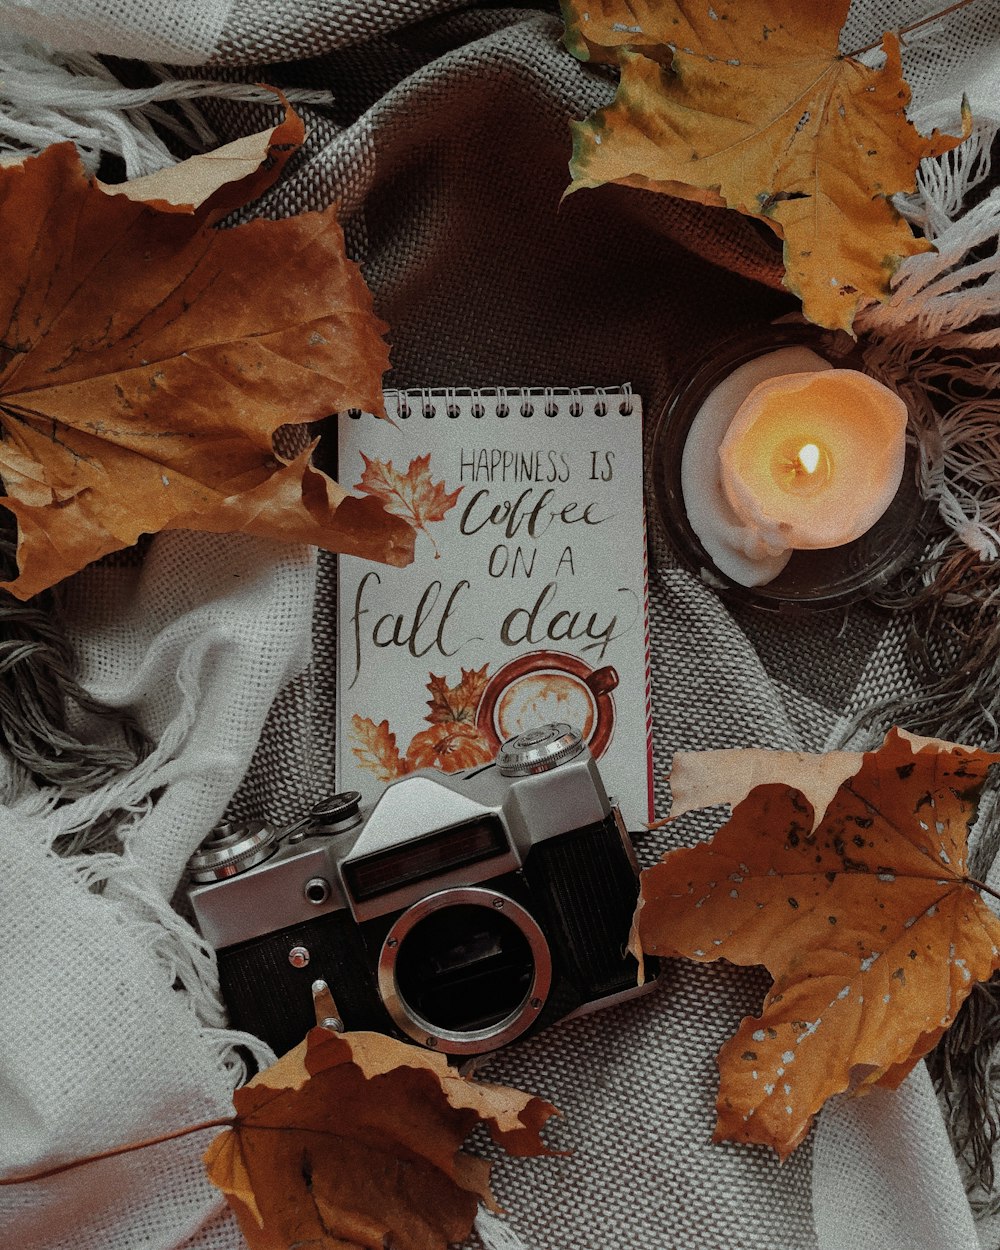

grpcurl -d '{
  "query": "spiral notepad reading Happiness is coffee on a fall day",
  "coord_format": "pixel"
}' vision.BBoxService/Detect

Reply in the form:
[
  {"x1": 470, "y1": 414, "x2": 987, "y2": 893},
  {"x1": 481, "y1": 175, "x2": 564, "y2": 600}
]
[{"x1": 338, "y1": 386, "x2": 651, "y2": 829}]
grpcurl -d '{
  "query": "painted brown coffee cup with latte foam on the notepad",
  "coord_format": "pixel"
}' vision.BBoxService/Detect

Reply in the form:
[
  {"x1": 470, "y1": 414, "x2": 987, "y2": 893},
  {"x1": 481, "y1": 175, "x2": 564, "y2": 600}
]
[{"x1": 476, "y1": 651, "x2": 618, "y2": 759}]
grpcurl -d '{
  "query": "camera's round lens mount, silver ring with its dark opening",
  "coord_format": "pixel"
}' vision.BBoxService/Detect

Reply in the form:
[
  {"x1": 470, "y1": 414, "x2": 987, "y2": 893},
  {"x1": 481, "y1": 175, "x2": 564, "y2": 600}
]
[{"x1": 378, "y1": 886, "x2": 553, "y2": 1055}]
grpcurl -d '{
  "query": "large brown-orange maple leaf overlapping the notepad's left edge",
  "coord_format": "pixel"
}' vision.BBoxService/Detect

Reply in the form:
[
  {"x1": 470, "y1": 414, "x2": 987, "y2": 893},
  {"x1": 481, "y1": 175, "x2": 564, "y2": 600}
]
[{"x1": 0, "y1": 115, "x2": 414, "y2": 599}]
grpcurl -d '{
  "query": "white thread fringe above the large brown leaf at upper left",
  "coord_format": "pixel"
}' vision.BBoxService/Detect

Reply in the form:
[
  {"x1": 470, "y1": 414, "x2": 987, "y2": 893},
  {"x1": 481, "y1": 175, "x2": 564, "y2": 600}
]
[{"x1": 0, "y1": 36, "x2": 333, "y2": 179}]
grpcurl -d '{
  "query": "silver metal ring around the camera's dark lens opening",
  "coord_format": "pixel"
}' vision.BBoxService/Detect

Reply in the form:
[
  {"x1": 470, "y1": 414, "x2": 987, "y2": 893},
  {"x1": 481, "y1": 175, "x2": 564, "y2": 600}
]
[{"x1": 378, "y1": 886, "x2": 553, "y2": 1055}]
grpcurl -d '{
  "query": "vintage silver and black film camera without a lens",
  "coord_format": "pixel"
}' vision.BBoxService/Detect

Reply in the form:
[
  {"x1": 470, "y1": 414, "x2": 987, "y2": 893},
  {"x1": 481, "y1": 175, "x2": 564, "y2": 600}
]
[{"x1": 189, "y1": 723, "x2": 655, "y2": 1055}]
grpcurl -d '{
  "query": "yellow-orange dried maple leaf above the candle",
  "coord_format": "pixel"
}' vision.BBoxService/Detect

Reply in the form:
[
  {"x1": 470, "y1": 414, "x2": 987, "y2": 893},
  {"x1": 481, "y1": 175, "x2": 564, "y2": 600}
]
[{"x1": 563, "y1": 0, "x2": 971, "y2": 330}]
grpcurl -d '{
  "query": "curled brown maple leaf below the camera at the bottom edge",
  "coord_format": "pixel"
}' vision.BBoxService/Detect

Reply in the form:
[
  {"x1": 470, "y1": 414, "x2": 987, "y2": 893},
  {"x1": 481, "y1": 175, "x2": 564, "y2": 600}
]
[{"x1": 205, "y1": 1029, "x2": 555, "y2": 1250}]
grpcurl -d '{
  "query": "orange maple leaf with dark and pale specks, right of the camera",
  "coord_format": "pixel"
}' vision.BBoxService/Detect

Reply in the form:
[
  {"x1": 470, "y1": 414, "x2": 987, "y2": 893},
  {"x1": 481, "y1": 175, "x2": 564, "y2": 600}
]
[{"x1": 634, "y1": 731, "x2": 1000, "y2": 1158}]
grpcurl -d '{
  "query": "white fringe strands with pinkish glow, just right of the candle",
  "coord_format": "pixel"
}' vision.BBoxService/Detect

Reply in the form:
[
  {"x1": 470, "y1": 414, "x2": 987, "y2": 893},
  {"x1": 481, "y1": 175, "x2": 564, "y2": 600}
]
[{"x1": 855, "y1": 120, "x2": 1000, "y2": 561}]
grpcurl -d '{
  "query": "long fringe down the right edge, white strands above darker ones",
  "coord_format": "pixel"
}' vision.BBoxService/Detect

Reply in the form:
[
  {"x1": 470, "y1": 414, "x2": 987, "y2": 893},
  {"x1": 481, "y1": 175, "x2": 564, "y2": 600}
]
[{"x1": 853, "y1": 126, "x2": 1000, "y2": 746}]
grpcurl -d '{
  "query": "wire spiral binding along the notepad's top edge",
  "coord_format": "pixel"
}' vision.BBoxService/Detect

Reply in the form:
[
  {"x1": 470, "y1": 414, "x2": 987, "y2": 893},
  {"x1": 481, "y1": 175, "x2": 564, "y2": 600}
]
[{"x1": 346, "y1": 383, "x2": 633, "y2": 421}]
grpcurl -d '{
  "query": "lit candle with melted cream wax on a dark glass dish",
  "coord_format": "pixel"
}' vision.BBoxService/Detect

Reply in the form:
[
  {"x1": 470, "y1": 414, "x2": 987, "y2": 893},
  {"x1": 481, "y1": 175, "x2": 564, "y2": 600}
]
[{"x1": 681, "y1": 348, "x2": 906, "y2": 586}]
